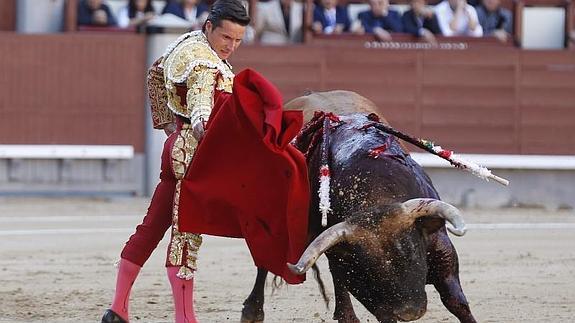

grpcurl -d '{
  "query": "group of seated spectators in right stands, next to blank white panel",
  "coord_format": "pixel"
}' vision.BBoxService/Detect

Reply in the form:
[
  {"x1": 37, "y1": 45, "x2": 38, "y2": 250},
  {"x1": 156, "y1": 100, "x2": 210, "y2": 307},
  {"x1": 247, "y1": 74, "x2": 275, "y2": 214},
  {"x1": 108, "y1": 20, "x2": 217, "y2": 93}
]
[{"x1": 313, "y1": 0, "x2": 513, "y2": 42}]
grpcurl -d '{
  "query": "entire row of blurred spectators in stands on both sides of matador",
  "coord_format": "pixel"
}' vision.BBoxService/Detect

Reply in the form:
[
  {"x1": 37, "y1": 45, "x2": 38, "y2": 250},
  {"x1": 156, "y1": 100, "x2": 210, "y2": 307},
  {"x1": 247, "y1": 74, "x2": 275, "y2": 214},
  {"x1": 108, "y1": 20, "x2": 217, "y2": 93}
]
[{"x1": 78, "y1": 0, "x2": 513, "y2": 44}]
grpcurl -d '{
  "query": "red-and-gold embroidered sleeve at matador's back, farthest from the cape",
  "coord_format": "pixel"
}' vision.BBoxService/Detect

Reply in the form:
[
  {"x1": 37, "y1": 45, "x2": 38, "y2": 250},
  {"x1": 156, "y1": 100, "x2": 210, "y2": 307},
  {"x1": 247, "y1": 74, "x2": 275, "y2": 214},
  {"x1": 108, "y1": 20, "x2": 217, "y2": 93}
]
[{"x1": 147, "y1": 58, "x2": 174, "y2": 129}]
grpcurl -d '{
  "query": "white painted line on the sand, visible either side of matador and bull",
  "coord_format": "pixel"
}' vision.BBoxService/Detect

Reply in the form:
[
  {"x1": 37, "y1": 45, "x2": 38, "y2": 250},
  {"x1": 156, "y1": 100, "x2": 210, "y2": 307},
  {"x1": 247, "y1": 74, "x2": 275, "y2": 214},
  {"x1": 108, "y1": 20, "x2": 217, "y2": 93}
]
[{"x1": 0, "y1": 223, "x2": 575, "y2": 236}]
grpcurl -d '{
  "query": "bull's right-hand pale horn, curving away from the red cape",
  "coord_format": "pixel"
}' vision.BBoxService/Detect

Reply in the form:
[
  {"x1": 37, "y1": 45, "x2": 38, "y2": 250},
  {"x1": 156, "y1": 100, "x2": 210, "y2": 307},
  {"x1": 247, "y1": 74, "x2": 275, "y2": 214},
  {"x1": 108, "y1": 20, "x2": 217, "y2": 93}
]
[{"x1": 402, "y1": 198, "x2": 467, "y2": 236}]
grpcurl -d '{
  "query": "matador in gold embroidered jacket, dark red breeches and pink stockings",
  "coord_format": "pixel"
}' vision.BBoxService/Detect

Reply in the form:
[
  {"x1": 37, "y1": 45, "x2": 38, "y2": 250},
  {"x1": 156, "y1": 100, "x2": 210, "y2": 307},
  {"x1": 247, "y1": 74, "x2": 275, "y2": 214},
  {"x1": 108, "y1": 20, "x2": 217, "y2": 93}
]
[{"x1": 102, "y1": 0, "x2": 250, "y2": 323}]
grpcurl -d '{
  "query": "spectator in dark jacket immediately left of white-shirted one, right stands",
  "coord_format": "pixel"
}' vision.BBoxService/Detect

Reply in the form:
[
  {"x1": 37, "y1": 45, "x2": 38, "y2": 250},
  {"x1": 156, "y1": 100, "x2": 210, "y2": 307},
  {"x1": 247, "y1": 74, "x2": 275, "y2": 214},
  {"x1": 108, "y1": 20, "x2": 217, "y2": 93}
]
[{"x1": 401, "y1": 0, "x2": 441, "y2": 44}]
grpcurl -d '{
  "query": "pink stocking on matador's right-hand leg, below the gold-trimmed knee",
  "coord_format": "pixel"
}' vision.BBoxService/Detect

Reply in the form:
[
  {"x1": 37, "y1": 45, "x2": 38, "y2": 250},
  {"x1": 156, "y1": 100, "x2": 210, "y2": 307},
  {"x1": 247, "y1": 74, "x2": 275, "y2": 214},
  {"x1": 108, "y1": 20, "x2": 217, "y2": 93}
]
[{"x1": 167, "y1": 267, "x2": 198, "y2": 323}]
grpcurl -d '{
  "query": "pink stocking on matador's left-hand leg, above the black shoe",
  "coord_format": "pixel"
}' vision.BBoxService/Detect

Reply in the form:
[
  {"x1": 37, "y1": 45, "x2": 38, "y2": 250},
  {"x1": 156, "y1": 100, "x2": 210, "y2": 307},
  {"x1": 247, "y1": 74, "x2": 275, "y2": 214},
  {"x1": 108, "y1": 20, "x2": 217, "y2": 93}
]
[{"x1": 111, "y1": 259, "x2": 142, "y2": 322}]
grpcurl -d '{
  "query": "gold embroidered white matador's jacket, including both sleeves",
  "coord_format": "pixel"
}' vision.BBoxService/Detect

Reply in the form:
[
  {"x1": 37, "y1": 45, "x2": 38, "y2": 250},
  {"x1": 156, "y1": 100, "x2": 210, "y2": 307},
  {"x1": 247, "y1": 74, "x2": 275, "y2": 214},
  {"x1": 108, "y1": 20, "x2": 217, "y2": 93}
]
[{"x1": 148, "y1": 30, "x2": 234, "y2": 129}]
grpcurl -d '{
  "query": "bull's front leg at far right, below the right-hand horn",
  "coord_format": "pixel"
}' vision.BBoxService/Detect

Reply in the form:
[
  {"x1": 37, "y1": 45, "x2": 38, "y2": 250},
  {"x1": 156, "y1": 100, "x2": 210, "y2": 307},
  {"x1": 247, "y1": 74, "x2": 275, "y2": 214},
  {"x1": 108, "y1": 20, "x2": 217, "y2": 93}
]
[{"x1": 428, "y1": 229, "x2": 476, "y2": 323}]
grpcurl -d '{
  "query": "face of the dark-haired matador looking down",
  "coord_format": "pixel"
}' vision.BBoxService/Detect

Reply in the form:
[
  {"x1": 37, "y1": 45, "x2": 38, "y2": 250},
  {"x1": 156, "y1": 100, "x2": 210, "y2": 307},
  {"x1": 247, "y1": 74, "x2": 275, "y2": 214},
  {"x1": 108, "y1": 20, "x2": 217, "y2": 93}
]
[{"x1": 206, "y1": 20, "x2": 246, "y2": 59}]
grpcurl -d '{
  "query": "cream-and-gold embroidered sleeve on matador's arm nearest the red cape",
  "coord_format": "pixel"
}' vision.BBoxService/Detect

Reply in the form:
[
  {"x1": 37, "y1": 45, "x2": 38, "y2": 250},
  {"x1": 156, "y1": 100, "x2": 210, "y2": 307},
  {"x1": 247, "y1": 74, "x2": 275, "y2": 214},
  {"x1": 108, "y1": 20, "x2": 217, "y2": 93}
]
[{"x1": 186, "y1": 65, "x2": 218, "y2": 127}]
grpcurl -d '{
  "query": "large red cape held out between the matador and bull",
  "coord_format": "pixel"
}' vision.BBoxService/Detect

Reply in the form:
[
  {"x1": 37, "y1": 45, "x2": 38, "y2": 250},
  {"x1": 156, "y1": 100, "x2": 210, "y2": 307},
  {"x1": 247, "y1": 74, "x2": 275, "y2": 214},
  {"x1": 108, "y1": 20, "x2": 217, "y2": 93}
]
[{"x1": 179, "y1": 69, "x2": 310, "y2": 284}]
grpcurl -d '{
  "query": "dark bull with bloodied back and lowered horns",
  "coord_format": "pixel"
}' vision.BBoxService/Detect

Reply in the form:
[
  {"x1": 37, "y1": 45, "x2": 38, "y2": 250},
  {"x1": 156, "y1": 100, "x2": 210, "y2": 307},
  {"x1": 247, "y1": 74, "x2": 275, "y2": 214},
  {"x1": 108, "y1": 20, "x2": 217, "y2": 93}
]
[{"x1": 242, "y1": 97, "x2": 475, "y2": 322}]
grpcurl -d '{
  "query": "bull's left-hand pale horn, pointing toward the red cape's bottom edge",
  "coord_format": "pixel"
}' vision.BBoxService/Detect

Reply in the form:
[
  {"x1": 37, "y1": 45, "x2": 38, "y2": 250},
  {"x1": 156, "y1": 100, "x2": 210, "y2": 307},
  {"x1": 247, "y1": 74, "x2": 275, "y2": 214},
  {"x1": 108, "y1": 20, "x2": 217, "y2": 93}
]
[{"x1": 287, "y1": 222, "x2": 357, "y2": 275}]
